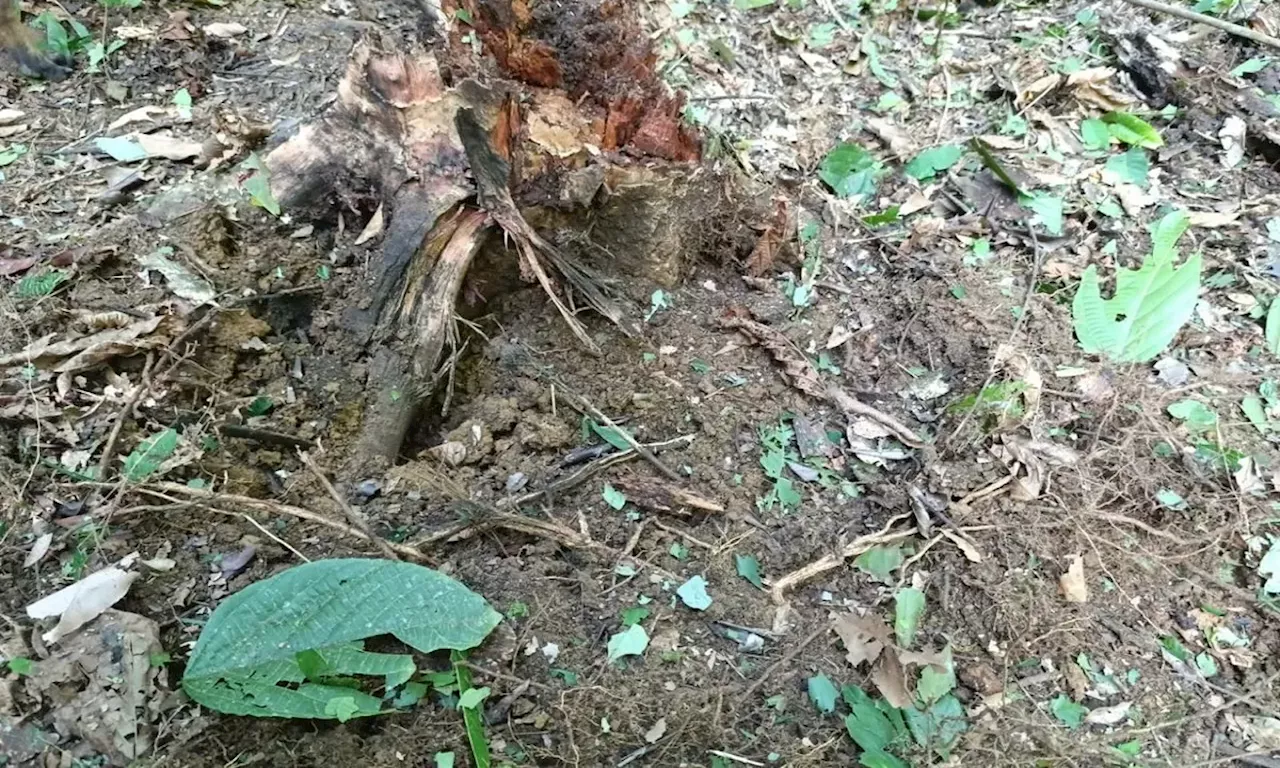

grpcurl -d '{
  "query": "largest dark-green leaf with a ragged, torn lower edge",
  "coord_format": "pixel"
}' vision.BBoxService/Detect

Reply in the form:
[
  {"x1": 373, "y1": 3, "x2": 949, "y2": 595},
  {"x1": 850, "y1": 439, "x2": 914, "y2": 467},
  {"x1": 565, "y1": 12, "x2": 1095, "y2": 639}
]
[{"x1": 182, "y1": 558, "x2": 502, "y2": 718}]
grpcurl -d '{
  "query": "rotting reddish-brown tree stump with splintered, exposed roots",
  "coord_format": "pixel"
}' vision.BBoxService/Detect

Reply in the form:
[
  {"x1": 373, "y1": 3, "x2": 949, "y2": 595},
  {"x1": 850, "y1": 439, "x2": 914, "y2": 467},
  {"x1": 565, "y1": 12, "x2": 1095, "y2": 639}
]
[{"x1": 248, "y1": 0, "x2": 742, "y2": 480}]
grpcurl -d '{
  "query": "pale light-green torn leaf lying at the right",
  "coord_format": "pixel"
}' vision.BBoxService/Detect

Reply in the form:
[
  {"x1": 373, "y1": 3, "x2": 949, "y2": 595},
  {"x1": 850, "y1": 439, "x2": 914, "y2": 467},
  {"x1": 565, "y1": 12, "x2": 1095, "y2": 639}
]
[{"x1": 1071, "y1": 211, "x2": 1201, "y2": 362}]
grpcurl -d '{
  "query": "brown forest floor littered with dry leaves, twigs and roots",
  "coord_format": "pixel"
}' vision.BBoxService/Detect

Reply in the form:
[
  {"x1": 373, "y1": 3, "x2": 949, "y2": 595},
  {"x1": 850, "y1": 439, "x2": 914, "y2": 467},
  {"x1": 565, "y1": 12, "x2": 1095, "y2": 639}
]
[{"x1": 0, "y1": 0, "x2": 1280, "y2": 768}]
